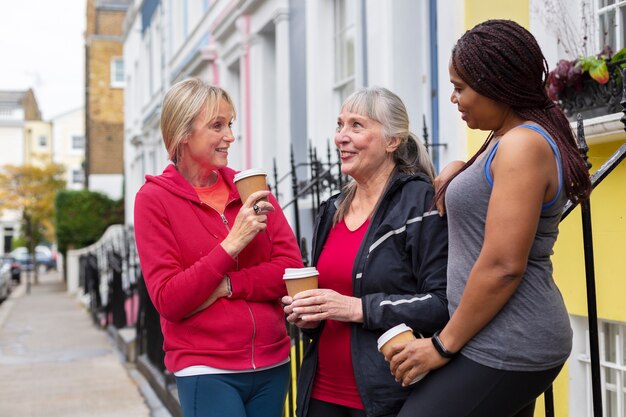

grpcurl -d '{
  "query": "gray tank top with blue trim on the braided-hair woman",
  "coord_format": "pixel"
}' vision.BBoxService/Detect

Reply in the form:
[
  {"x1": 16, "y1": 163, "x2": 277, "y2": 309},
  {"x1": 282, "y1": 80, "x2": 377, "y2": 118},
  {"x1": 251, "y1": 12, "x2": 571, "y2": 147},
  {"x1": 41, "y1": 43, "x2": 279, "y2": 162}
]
[{"x1": 446, "y1": 125, "x2": 572, "y2": 371}]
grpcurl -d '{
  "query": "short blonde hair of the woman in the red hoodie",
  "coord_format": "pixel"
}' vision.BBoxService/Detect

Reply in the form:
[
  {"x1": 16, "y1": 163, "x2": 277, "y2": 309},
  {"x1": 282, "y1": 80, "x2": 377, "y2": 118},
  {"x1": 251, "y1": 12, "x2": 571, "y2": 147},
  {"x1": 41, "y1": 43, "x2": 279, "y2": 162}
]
[{"x1": 161, "y1": 78, "x2": 235, "y2": 164}]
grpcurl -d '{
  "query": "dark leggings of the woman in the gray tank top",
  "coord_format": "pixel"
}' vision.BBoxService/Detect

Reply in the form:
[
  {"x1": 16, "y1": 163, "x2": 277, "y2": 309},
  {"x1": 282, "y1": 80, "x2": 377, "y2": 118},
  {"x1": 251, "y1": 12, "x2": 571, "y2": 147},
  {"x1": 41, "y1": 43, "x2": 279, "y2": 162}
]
[{"x1": 398, "y1": 355, "x2": 563, "y2": 417}]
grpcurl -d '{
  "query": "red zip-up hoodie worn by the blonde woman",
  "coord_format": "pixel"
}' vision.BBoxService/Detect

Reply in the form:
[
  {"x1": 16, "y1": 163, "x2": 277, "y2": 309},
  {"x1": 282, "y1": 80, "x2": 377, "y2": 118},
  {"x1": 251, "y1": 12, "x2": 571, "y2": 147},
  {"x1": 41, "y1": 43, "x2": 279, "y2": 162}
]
[{"x1": 135, "y1": 165, "x2": 302, "y2": 372}]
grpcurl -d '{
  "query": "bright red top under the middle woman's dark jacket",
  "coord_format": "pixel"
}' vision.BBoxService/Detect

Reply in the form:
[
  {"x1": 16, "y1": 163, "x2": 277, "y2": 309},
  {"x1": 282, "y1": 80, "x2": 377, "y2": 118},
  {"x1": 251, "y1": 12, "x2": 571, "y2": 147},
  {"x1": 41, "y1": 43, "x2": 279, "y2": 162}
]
[{"x1": 311, "y1": 220, "x2": 369, "y2": 410}]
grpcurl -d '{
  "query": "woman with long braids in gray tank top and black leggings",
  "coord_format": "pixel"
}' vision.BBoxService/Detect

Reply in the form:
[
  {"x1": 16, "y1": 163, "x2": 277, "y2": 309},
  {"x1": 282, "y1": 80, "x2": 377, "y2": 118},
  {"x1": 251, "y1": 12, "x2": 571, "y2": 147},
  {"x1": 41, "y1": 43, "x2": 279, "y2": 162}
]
[{"x1": 380, "y1": 20, "x2": 591, "y2": 417}]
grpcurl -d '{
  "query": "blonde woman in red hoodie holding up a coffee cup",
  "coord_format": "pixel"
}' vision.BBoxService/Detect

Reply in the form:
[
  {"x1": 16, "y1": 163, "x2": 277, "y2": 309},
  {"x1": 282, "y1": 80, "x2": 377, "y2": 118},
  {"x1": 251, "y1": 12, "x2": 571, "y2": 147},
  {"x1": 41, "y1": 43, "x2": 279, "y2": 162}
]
[{"x1": 135, "y1": 79, "x2": 302, "y2": 417}]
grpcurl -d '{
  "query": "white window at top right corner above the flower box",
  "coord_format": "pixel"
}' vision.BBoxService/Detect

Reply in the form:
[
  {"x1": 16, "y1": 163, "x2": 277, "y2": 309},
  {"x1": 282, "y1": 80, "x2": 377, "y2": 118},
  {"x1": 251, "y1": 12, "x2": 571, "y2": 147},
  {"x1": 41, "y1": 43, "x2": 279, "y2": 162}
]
[{"x1": 596, "y1": 0, "x2": 626, "y2": 52}]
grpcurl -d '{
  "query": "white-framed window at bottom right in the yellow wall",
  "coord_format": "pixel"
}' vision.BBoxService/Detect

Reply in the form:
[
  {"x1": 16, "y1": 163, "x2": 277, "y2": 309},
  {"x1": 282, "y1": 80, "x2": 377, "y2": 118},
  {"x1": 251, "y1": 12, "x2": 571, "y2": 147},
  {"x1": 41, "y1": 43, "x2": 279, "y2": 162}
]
[{"x1": 578, "y1": 321, "x2": 626, "y2": 417}]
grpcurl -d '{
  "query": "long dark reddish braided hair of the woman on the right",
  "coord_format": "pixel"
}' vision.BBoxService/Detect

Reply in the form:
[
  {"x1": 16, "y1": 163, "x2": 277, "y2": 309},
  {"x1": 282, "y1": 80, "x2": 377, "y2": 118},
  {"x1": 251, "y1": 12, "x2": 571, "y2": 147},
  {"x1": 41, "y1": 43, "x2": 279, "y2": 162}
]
[{"x1": 436, "y1": 20, "x2": 591, "y2": 203}]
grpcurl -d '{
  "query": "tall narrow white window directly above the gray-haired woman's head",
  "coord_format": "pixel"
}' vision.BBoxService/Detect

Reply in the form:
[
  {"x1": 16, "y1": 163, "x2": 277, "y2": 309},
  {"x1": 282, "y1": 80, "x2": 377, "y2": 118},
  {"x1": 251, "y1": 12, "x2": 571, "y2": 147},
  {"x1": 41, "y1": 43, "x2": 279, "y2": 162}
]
[{"x1": 334, "y1": 0, "x2": 354, "y2": 102}]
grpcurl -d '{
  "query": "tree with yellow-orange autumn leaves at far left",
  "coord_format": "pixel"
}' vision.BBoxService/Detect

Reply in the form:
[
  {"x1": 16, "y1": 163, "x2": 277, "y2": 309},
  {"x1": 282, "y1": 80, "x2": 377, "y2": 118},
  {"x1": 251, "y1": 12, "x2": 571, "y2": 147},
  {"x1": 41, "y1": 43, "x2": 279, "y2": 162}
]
[{"x1": 0, "y1": 163, "x2": 65, "y2": 283}]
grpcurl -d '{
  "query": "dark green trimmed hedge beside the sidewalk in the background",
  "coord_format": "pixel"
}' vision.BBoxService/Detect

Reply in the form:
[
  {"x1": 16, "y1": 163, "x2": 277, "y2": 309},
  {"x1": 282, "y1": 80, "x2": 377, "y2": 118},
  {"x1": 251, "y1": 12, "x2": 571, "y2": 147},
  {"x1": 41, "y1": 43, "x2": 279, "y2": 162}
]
[{"x1": 55, "y1": 190, "x2": 124, "y2": 255}]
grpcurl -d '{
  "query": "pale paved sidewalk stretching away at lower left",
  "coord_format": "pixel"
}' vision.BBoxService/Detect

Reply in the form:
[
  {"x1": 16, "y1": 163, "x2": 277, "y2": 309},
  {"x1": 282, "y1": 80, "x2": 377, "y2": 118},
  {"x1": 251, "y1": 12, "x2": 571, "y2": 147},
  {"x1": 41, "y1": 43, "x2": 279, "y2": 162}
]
[{"x1": 0, "y1": 272, "x2": 167, "y2": 417}]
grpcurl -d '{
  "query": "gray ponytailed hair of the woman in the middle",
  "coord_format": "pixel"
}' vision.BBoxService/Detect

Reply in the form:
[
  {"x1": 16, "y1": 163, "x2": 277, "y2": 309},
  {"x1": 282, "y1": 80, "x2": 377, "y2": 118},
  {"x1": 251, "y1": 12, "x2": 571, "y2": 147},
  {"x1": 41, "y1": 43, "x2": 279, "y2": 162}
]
[{"x1": 333, "y1": 87, "x2": 435, "y2": 224}]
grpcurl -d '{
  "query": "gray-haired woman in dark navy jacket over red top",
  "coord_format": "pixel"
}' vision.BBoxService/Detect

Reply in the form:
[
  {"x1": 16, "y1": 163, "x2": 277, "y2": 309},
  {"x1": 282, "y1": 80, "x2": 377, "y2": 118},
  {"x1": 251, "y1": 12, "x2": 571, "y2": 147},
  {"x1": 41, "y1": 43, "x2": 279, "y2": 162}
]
[{"x1": 283, "y1": 88, "x2": 448, "y2": 417}]
